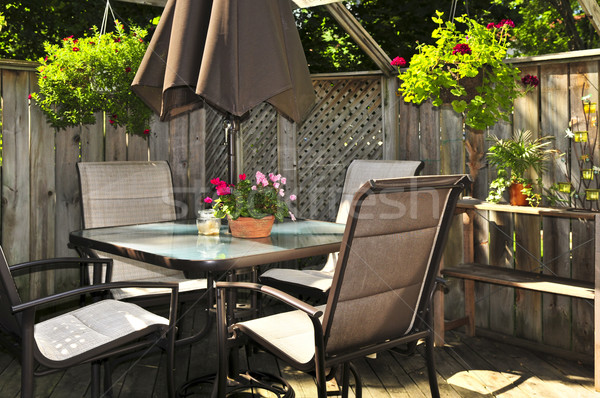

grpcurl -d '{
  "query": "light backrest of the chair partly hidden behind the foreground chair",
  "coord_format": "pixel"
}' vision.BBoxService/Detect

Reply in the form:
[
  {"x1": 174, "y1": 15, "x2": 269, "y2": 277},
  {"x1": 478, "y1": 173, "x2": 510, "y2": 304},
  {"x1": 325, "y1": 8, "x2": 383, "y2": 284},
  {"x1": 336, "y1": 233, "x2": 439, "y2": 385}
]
[{"x1": 322, "y1": 159, "x2": 423, "y2": 274}]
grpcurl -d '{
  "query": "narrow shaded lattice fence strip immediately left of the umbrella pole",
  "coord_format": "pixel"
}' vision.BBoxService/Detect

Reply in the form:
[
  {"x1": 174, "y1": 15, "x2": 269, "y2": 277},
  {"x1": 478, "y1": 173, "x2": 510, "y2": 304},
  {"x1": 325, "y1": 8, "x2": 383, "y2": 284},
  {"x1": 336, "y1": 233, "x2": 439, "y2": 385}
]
[{"x1": 205, "y1": 105, "x2": 229, "y2": 182}]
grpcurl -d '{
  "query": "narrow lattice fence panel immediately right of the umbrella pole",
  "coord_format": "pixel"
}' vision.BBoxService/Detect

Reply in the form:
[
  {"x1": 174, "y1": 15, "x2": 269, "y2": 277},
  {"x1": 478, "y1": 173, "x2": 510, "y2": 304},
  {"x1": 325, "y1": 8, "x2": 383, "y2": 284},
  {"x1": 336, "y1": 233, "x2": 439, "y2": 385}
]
[{"x1": 240, "y1": 103, "x2": 277, "y2": 175}]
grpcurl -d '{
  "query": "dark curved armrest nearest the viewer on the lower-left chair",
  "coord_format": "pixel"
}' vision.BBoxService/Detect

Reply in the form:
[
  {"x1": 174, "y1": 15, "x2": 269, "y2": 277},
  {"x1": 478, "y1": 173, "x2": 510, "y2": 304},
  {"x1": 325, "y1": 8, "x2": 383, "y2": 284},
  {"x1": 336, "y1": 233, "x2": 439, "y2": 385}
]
[{"x1": 12, "y1": 281, "x2": 179, "y2": 313}]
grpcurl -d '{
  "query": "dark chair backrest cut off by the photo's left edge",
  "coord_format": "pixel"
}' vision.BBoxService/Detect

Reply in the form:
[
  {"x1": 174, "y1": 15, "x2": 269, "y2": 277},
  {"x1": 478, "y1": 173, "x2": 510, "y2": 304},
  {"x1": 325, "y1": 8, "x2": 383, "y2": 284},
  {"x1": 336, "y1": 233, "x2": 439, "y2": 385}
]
[{"x1": 0, "y1": 247, "x2": 21, "y2": 336}]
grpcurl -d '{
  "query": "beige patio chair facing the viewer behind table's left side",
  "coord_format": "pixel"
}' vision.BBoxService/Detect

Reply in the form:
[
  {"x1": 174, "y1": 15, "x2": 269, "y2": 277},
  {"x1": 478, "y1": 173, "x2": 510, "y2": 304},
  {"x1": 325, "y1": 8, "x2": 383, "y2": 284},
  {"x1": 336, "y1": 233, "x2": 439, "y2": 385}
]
[{"x1": 77, "y1": 161, "x2": 212, "y2": 344}]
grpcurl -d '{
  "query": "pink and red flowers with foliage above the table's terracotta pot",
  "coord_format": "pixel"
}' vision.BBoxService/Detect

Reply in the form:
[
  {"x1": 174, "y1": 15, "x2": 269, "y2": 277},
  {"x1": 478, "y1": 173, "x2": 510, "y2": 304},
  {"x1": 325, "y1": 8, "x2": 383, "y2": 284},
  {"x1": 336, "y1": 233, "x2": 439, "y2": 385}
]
[{"x1": 204, "y1": 171, "x2": 296, "y2": 221}]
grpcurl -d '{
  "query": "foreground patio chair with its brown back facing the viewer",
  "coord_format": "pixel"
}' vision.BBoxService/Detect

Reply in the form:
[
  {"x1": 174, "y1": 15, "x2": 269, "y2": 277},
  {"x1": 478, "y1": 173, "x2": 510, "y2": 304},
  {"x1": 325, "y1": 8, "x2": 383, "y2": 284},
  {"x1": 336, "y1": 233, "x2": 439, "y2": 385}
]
[{"x1": 215, "y1": 175, "x2": 469, "y2": 398}]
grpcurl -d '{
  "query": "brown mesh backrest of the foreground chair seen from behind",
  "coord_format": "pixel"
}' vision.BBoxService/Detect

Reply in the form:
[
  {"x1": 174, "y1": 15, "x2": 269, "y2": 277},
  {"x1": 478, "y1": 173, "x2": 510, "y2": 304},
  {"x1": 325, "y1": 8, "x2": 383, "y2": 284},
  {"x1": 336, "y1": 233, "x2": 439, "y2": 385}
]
[{"x1": 323, "y1": 175, "x2": 469, "y2": 356}]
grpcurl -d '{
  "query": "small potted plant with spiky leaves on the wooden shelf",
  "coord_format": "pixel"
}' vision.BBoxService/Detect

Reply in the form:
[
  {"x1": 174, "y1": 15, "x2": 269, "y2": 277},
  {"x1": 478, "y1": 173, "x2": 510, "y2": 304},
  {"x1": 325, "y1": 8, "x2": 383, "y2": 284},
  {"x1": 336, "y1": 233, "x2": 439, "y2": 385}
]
[{"x1": 487, "y1": 130, "x2": 553, "y2": 206}]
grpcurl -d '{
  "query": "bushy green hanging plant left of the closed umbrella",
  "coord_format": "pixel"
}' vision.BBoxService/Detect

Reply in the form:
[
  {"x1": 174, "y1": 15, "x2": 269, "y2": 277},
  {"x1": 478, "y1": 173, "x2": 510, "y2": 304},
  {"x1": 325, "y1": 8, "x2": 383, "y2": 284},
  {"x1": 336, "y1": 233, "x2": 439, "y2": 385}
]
[{"x1": 31, "y1": 21, "x2": 152, "y2": 136}]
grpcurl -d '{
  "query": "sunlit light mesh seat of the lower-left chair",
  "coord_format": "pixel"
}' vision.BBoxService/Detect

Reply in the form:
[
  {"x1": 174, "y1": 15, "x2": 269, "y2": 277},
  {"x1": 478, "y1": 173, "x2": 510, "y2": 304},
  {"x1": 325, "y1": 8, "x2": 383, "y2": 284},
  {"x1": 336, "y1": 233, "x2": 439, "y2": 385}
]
[{"x1": 34, "y1": 300, "x2": 170, "y2": 361}]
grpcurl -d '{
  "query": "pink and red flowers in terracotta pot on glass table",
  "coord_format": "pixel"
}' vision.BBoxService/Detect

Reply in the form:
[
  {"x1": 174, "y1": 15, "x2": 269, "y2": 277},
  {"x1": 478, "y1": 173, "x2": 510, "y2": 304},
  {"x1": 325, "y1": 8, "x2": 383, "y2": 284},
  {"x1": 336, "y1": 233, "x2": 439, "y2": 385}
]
[{"x1": 204, "y1": 171, "x2": 296, "y2": 238}]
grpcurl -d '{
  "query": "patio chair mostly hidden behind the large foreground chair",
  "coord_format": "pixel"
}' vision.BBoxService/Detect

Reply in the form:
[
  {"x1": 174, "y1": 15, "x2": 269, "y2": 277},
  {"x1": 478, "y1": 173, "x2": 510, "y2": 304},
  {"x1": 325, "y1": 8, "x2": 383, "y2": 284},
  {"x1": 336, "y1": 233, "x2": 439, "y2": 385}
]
[{"x1": 259, "y1": 160, "x2": 423, "y2": 302}]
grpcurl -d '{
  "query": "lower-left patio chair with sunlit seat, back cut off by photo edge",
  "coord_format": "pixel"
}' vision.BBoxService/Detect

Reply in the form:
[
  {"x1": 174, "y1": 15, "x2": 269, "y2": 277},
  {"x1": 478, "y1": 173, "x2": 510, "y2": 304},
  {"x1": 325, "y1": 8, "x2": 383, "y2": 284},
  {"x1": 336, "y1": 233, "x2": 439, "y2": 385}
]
[{"x1": 0, "y1": 247, "x2": 178, "y2": 398}]
